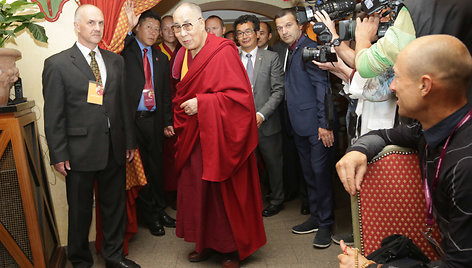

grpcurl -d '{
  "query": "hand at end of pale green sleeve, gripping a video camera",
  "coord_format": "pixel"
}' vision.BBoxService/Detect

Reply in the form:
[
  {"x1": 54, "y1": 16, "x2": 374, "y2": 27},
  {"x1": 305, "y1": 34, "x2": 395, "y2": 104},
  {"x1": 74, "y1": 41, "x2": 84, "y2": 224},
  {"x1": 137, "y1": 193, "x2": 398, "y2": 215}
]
[{"x1": 355, "y1": 14, "x2": 380, "y2": 53}]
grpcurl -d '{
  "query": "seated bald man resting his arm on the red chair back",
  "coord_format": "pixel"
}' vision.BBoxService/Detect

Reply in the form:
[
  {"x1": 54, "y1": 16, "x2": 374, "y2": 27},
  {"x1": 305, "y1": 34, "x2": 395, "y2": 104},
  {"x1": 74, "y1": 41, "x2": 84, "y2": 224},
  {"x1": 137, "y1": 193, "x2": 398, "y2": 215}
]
[{"x1": 336, "y1": 35, "x2": 472, "y2": 267}]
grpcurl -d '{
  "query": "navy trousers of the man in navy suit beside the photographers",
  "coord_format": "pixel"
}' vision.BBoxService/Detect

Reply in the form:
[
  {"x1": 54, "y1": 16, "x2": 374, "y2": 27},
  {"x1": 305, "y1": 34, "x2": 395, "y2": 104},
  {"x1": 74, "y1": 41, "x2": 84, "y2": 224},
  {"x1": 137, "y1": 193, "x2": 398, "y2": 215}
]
[{"x1": 294, "y1": 134, "x2": 334, "y2": 227}]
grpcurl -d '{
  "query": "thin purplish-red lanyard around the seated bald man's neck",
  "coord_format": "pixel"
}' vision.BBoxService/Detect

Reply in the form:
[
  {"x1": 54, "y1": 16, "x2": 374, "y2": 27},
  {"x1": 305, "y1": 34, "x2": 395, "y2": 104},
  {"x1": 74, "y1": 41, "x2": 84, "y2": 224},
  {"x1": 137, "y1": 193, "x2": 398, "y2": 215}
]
[{"x1": 423, "y1": 109, "x2": 472, "y2": 229}]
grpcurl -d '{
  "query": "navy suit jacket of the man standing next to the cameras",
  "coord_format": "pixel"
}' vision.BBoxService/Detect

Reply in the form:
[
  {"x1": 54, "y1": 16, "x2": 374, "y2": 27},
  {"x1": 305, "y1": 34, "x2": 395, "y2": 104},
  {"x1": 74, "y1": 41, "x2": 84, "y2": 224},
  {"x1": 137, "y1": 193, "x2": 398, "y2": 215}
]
[{"x1": 279, "y1": 36, "x2": 329, "y2": 136}]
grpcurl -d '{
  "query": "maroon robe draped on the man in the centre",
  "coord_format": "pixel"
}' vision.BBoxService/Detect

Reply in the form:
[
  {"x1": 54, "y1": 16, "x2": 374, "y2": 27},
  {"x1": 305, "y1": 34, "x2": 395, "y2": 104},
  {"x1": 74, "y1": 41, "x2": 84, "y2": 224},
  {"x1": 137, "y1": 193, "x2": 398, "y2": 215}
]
[{"x1": 172, "y1": 34, "x2": 266, "y2": 260}]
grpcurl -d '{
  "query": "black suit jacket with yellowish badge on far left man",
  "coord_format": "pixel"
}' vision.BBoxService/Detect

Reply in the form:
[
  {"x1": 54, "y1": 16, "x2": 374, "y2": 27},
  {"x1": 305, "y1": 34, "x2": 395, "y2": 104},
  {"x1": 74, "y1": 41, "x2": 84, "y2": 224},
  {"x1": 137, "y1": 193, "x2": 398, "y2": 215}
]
[{"x1": 43, "y1": 44, "x2": 136, "y2": 171}]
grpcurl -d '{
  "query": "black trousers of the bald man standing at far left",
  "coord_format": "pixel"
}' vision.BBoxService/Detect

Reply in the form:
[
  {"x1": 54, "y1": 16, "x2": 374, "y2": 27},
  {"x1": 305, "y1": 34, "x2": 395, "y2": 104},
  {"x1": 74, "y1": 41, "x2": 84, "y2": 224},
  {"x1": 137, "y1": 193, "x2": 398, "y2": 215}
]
[{"x1": 66, "y1": 143, "x2": 126, "y2": 267}]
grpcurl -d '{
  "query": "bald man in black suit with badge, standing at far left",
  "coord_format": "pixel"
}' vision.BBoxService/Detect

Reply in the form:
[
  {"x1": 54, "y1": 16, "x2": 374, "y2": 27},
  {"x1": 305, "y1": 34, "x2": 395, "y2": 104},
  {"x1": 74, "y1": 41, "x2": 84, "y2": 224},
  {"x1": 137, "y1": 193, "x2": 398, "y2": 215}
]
[{"x1": 43, "y1": 5, "x2": 140, "y2": 268}]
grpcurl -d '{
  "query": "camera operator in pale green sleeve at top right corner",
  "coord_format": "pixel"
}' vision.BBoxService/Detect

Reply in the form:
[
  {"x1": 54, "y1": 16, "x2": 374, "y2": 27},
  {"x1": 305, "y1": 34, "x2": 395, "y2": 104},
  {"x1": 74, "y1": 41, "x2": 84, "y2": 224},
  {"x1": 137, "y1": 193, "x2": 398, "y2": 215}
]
[{"x1": 355, "y1": 0, "x2": 472, "y2": 82}]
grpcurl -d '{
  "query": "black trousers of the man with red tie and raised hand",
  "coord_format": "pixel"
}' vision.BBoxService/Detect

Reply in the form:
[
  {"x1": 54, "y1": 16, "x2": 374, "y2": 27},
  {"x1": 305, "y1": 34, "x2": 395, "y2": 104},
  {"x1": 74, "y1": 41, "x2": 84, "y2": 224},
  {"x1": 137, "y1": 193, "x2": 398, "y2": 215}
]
[{"x1": 135, "y1": 115, "x2": 166, "y2": 217}]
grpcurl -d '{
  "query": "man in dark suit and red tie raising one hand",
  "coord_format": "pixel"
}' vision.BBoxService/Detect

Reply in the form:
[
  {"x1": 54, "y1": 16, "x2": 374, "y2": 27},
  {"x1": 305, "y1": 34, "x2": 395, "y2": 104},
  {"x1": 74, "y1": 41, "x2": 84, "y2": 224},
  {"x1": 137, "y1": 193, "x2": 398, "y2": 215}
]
[{"x1": 121, "y1": 1, "x2": 175, "y2": 235}]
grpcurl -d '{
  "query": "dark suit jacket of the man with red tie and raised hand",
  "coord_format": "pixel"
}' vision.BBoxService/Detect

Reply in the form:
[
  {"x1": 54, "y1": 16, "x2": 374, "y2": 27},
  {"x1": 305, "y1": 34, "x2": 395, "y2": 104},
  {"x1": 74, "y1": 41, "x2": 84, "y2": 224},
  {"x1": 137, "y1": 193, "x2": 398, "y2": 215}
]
[{"x1": 121, "y1": 36, "x2": 172, "y2": 150}]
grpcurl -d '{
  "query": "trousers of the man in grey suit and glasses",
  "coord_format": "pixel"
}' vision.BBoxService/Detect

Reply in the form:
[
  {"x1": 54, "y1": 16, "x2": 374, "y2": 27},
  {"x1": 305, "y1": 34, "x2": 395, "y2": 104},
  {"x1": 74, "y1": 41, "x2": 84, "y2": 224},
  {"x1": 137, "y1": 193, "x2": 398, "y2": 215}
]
[{"x1": 257, "y1": 132, "x2": 285, "y2": 205}]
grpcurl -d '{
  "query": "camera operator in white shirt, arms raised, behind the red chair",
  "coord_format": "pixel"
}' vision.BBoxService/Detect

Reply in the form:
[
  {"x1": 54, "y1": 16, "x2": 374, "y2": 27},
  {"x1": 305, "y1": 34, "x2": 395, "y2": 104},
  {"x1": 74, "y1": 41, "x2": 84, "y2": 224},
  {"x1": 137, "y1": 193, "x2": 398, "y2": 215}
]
[{"x1": 313, "y1": 10, "x2": 396, "y2": 245}]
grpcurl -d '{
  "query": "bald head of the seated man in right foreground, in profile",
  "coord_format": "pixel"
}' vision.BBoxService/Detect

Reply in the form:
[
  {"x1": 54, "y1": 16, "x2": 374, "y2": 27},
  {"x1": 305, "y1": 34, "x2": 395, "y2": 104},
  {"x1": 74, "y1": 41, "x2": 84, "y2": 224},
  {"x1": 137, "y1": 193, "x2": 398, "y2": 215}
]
[{"x1": 390, "y1": 35, "x2": 472, "y2": 129}]
